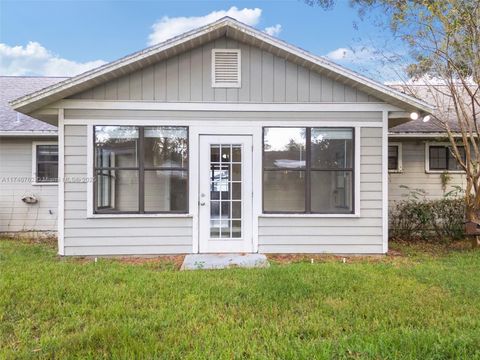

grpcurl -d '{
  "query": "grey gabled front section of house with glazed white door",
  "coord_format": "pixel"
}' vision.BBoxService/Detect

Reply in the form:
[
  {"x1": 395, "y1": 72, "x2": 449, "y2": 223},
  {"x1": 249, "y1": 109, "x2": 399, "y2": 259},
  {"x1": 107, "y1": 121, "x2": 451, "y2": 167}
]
[{"x1": 4, "y1": 18, "x2": 433, "y2": 255}]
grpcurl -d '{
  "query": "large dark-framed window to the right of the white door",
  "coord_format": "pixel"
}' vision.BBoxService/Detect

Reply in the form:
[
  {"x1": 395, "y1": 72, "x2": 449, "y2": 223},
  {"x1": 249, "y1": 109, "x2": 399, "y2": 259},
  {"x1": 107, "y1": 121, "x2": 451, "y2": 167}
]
[{"x1": 263, "y1": 127, "x2": 354, "y2": 214}]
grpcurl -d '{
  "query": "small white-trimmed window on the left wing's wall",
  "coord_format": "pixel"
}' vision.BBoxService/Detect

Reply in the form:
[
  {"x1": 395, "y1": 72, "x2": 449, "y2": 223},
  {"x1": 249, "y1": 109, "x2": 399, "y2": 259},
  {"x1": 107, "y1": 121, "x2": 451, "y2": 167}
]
[{"x1": 33, "y1": 142, "x2": 58, "y2": 184}]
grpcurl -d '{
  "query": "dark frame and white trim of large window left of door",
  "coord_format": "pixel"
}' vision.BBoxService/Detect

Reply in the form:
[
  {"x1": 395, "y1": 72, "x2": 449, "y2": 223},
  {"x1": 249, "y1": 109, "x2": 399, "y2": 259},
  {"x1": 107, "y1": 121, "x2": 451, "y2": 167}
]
[{"x1": 89, "y1": 124, "x2": 190, "y2": 214}]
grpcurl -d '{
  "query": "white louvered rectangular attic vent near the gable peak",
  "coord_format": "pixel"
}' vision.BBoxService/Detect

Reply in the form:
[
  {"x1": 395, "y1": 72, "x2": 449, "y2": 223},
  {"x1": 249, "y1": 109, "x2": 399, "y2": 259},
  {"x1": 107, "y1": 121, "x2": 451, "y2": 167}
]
[{"x1": 212, "y1": 49, "x2": 241, "y2": 87}]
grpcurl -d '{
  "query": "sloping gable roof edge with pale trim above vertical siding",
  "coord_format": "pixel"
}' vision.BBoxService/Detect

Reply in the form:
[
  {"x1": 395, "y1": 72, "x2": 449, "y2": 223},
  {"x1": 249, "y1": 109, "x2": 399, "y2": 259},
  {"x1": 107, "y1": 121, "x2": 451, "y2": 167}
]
[{"x1": 11, "y1": 17, "x2": 433, "y2": 114}]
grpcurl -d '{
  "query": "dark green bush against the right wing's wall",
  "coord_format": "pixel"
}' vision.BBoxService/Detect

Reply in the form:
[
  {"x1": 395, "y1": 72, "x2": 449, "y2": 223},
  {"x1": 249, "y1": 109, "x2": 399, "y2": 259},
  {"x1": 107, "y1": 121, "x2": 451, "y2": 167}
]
[{"x1": 389, "y1": 186, "x2": 465, "y2": 241}]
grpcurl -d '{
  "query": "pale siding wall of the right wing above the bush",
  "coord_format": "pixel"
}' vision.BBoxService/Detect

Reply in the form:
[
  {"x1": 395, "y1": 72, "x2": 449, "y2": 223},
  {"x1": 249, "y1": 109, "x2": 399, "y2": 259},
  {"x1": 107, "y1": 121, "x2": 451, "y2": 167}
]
[{"x1": 388, "y1": 137, "x2": 465, "y2": 202}]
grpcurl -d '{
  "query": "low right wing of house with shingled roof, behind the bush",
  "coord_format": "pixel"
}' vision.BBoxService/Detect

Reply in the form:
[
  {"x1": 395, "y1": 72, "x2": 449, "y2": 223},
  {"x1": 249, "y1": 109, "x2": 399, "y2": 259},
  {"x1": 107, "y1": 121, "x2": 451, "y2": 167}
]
[{"x1": 388, "y1": 85, "x2": 465, "y2": 202}]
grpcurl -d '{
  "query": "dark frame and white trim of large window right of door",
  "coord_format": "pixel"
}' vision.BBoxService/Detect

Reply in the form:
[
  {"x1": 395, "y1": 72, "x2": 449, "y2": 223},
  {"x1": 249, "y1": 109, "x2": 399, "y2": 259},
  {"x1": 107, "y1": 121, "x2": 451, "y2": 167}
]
[{"x1": 260, "y1": 125, "x2": 360, "y2": 217}]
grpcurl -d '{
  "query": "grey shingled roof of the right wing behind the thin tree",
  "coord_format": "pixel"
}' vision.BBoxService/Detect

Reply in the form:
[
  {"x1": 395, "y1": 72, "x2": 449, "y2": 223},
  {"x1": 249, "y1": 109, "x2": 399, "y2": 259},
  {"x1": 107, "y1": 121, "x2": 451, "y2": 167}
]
[{"x1": 389, "y1": 84, "x2": 474, "y2": 134}]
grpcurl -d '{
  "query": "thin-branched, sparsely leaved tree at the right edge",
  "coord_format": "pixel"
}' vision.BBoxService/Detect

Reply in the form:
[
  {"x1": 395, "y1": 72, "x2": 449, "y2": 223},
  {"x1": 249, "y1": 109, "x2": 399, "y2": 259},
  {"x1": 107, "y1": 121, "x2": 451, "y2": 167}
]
[{"x1": 306, "y1": 0, "x2": 480, "y2": 246}]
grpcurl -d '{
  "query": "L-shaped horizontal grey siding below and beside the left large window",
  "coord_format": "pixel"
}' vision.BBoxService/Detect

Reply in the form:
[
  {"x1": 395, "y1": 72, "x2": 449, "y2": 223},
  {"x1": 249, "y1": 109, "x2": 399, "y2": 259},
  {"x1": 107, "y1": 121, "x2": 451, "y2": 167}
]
[{"x1": 64, "y1": 125, "x2": 192, "y2": 255}]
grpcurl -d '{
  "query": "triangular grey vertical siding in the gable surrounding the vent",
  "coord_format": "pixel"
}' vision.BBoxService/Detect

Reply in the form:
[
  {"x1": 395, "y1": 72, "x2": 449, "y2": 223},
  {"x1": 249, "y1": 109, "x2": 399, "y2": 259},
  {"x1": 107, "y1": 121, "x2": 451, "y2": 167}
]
[{"x1": 70, "y1": 37, "x2": 382, "y2": 103}]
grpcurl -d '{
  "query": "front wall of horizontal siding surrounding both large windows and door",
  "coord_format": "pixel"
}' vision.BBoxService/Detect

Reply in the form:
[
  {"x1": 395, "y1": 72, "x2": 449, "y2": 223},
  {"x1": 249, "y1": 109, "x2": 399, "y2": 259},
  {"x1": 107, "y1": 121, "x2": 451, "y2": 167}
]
[{"x1": 64, "y1": 110, "x2": 384, "y2": 255}]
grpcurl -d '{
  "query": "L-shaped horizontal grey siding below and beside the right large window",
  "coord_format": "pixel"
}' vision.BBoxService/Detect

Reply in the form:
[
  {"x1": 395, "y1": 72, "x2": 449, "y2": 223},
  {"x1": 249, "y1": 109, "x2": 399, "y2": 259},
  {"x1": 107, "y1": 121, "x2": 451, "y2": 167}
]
[{"x1": 258, "y1": 128, "x2": 383, "y2": 253}]
